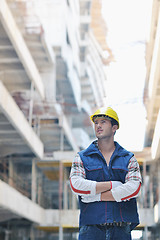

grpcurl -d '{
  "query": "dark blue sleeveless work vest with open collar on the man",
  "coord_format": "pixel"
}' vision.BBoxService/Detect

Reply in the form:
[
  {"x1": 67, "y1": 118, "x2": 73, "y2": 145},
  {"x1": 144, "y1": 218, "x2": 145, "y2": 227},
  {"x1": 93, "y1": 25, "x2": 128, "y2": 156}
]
[{"x1": 79, "y1": 142, "x2": 139, "y2": 230}]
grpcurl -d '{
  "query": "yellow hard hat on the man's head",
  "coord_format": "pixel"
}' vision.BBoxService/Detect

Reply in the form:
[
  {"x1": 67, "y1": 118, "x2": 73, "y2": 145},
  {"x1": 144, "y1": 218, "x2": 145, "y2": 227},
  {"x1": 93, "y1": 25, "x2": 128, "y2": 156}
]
[{"x1": 90, "y1": 107, "x2": 119, "y2": 128}]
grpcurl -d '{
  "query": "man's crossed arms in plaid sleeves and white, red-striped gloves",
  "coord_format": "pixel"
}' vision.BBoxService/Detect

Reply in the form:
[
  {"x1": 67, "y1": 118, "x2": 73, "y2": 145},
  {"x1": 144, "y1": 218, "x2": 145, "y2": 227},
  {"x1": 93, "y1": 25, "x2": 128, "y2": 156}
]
[{"x1": 70, "y1": 155, "x2": 141, "y2": 202}]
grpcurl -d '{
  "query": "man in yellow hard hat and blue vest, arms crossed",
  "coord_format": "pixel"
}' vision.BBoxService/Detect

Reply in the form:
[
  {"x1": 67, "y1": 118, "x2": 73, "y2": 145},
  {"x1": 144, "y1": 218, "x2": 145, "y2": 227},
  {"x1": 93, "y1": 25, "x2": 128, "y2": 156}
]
[{"x1": 70, "y1": 107, "x2": 141, "y2": 240}]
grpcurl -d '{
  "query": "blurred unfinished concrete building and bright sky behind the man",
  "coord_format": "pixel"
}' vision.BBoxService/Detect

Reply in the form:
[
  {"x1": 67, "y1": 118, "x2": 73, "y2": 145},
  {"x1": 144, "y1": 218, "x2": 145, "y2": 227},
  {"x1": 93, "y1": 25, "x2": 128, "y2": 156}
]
[{"x1": 0, "y1": 0, "x2": 160, "y2": 240}]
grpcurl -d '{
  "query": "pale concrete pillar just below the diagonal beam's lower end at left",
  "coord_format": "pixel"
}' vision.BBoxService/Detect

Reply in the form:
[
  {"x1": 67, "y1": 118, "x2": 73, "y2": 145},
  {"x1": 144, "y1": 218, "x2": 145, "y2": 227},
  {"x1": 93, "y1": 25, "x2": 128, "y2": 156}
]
[{"x1": 31, "y1": 159, "x2": 37, "y2": 202}]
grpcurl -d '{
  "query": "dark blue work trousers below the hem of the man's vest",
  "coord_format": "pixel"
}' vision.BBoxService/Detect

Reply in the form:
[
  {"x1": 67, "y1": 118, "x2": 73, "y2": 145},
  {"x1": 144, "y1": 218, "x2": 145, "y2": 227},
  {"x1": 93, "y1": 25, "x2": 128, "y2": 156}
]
[{"x1": 78, "y1": 225, "x2": 132, "y2": 240}]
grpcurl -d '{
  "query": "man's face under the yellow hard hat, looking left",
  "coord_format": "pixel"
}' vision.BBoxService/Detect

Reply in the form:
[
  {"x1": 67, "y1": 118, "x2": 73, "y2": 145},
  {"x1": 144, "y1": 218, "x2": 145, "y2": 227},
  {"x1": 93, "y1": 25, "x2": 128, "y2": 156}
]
[{"x1": 94, "y1": 117, "x2": 116, "y2": 139}]
